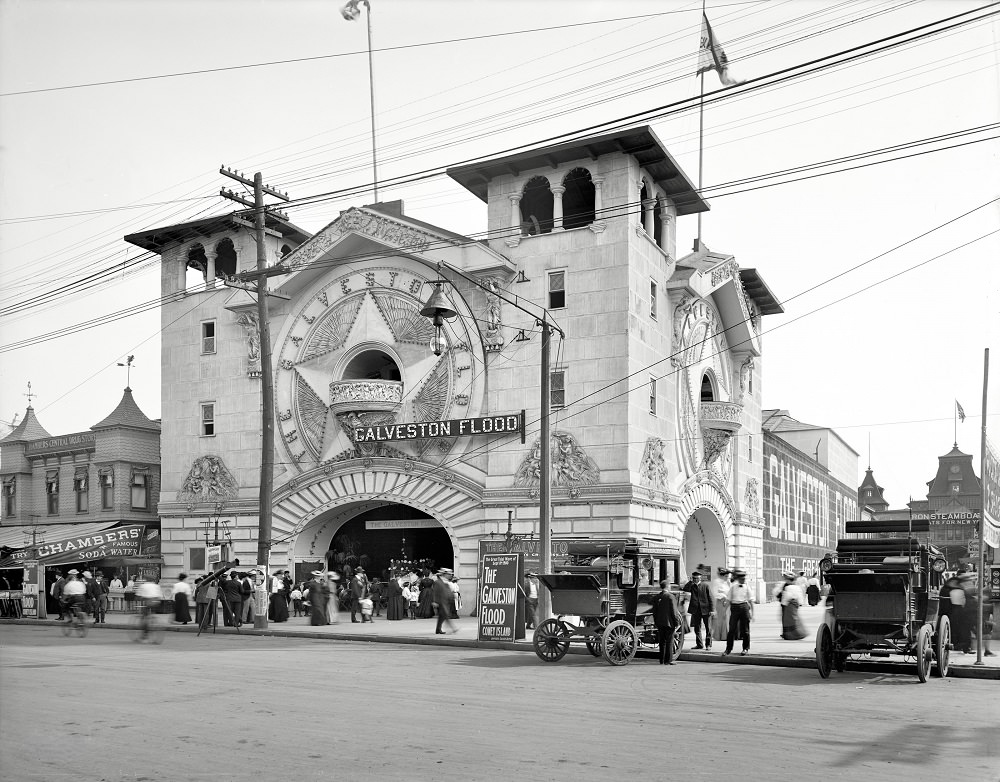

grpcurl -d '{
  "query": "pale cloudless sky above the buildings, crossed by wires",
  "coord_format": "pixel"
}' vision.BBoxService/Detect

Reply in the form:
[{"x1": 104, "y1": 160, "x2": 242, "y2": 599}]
[{"x1": 0, "y1": 0, "x2": 1000, "y2": 507}]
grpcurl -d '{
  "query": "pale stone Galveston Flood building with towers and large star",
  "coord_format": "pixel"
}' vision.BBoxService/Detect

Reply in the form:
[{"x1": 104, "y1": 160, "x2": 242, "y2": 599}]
[{"x1": 126, "y1": 127, "x2": 782, "y2": 596}]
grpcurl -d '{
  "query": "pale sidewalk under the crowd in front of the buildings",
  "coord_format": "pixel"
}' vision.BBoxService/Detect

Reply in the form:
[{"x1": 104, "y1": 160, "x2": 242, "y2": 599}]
[{"x1": 0, "y1": 603, "x2": 1000, "y2": 680}]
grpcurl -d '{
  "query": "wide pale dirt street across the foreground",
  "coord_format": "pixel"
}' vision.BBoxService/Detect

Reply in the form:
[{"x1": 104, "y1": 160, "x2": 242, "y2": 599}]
[{"x1": 0, "y1": 626, "x2": 1000, "y2": 782}]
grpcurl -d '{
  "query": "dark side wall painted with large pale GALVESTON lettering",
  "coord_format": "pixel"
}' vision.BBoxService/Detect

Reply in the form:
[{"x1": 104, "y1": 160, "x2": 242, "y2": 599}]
[{"x1": 763, "y1": 435, "x2": 858, "y2": 586}]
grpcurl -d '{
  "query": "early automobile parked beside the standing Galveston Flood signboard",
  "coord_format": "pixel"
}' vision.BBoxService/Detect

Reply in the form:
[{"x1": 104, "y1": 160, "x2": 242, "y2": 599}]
[{"x1": 532, "y1": 538, "x2": 684, "y2": 665}]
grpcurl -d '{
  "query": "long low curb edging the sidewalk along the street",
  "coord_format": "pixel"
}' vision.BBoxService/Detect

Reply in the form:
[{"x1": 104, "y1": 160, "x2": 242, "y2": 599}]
[{"x1": 0, "y1": 618, "x2": 1000, "y2": 681}]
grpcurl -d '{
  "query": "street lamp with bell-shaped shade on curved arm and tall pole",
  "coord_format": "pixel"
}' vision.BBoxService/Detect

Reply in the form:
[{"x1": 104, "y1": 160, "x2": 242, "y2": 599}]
[{"x1": 420, "y1": 270, "x2": 565, "y2": 619}]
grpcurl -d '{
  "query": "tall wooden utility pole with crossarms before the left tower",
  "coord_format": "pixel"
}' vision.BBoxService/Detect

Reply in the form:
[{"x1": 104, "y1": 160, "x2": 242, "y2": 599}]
[{"x1": 219, "y1": 167, "x2": 289, "y2": 630}]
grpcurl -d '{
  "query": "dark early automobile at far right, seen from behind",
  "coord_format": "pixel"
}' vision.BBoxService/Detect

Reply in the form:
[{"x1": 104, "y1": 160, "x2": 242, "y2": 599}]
[{"x1": 816, "y1": 521, "x2": 951, "y2": 682}]
